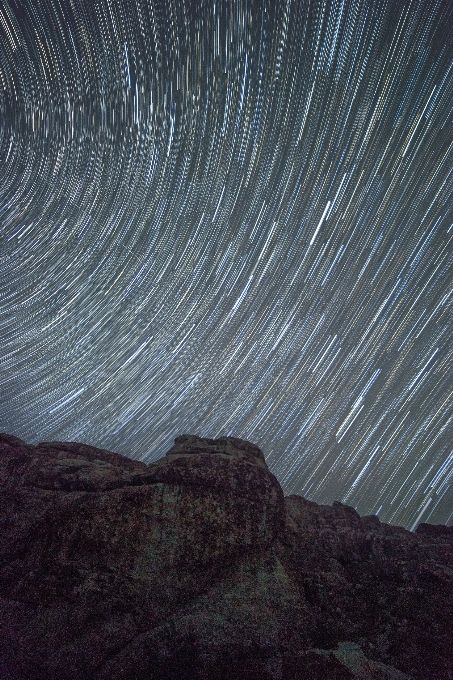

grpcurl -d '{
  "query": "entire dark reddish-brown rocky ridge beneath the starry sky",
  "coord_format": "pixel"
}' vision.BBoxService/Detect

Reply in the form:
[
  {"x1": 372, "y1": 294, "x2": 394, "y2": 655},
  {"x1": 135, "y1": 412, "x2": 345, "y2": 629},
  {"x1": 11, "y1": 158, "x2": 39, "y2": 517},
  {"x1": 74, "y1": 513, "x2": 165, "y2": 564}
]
[{"x1": 0, "y1": 434, "x2": 453, "y2": 680}]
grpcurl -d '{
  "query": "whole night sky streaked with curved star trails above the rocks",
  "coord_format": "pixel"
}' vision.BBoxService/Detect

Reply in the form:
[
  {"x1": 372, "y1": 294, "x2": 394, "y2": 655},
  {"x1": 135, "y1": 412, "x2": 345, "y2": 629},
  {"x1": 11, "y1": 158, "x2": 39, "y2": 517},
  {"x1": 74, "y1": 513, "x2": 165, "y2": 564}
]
[{"x1": 0, "y1": 0, "x2": 453, "y2": 528}]
